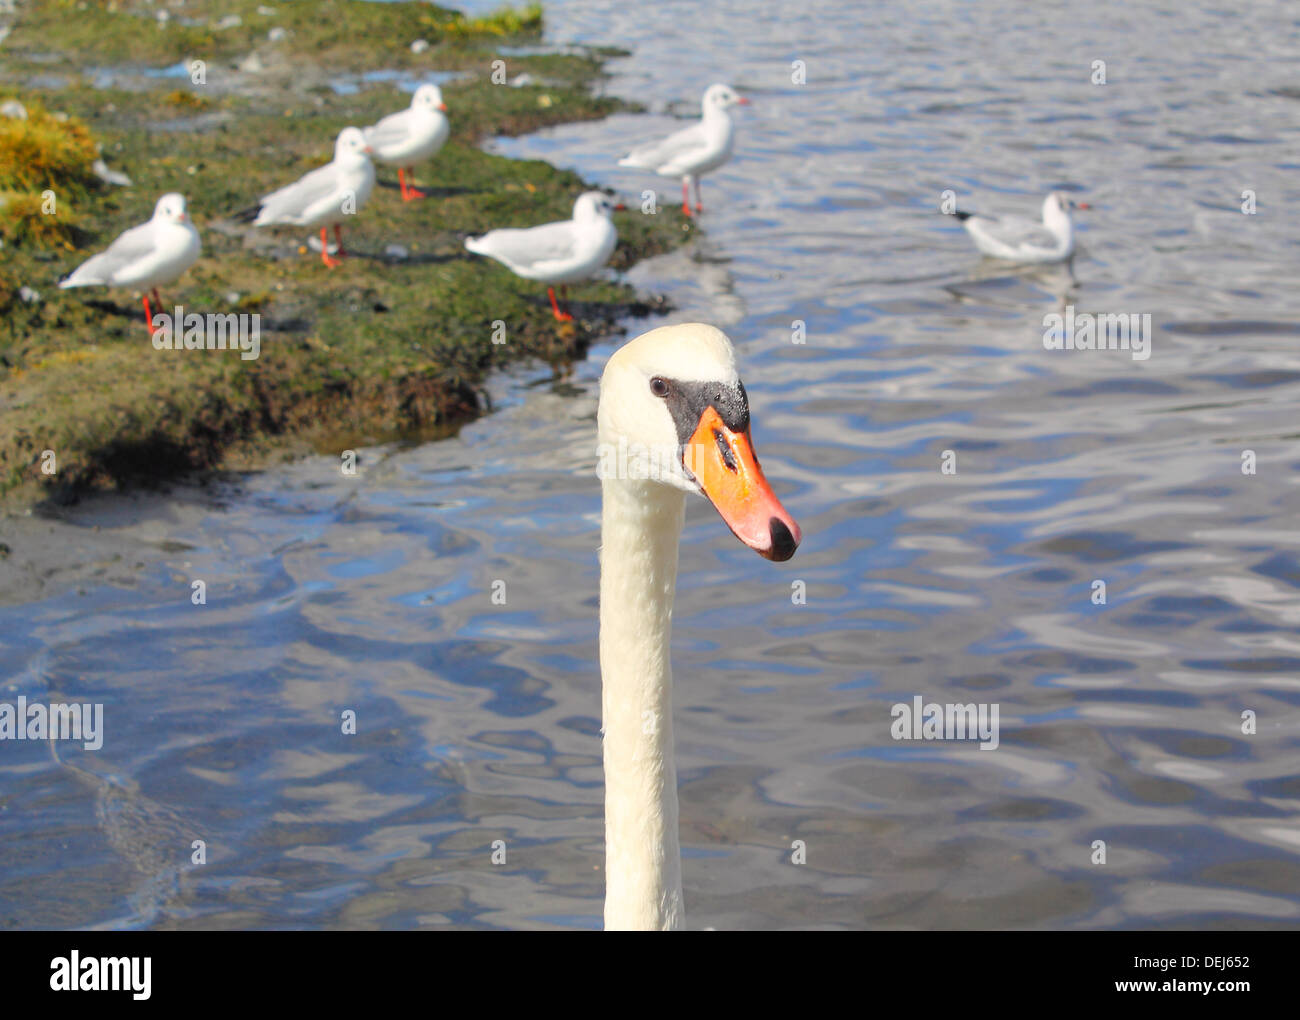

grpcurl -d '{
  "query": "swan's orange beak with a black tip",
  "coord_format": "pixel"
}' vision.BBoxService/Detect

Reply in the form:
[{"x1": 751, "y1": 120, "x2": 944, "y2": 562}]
[{"x1": 683, "y1": 407, "x2": 803, "y2": 560}]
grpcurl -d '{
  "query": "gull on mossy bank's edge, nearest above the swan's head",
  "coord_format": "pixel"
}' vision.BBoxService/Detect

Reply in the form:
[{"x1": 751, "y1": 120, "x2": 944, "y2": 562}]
[{"x1": 465, "y1": 191, "x2": 624, "y2": 322}]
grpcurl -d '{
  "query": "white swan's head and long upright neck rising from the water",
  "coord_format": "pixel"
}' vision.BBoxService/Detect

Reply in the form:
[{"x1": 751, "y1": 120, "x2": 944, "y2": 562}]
[{"x1": 597, "y1": 322, "x2": 801, "y2": 930}]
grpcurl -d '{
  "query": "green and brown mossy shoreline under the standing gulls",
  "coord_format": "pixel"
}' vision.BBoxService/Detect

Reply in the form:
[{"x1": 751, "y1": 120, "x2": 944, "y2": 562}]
[{"x1": 0, "y1": 0, "x2": 693, "y2": 508}]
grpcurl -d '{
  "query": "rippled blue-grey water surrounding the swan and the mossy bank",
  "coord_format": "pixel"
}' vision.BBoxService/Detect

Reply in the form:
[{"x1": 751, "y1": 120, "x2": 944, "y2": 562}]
[{"x1": 0, "y1": 0, "x2": 1300, "y2": 928}]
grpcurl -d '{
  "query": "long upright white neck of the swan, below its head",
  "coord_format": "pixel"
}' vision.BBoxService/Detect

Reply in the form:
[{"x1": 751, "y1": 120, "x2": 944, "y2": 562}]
[{"x1": 601, "y1": 478, "x2": 685, "y2": 929}]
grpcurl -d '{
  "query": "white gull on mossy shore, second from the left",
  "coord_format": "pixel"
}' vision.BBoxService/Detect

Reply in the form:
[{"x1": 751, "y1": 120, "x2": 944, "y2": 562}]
[{"x1": 238, "y1": 127, "x2": 374, "y2": 269}]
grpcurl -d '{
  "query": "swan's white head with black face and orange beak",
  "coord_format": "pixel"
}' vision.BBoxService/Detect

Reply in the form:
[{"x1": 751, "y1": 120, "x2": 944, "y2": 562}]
[{"x1": 597, "y1": 322, "x2": 802, "y2": 560}]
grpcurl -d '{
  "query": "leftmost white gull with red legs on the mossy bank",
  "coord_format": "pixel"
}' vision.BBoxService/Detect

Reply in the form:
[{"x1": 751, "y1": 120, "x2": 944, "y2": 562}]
[{"x1": 59, "y1": 192, "x2": 203, "y2": 337}]
